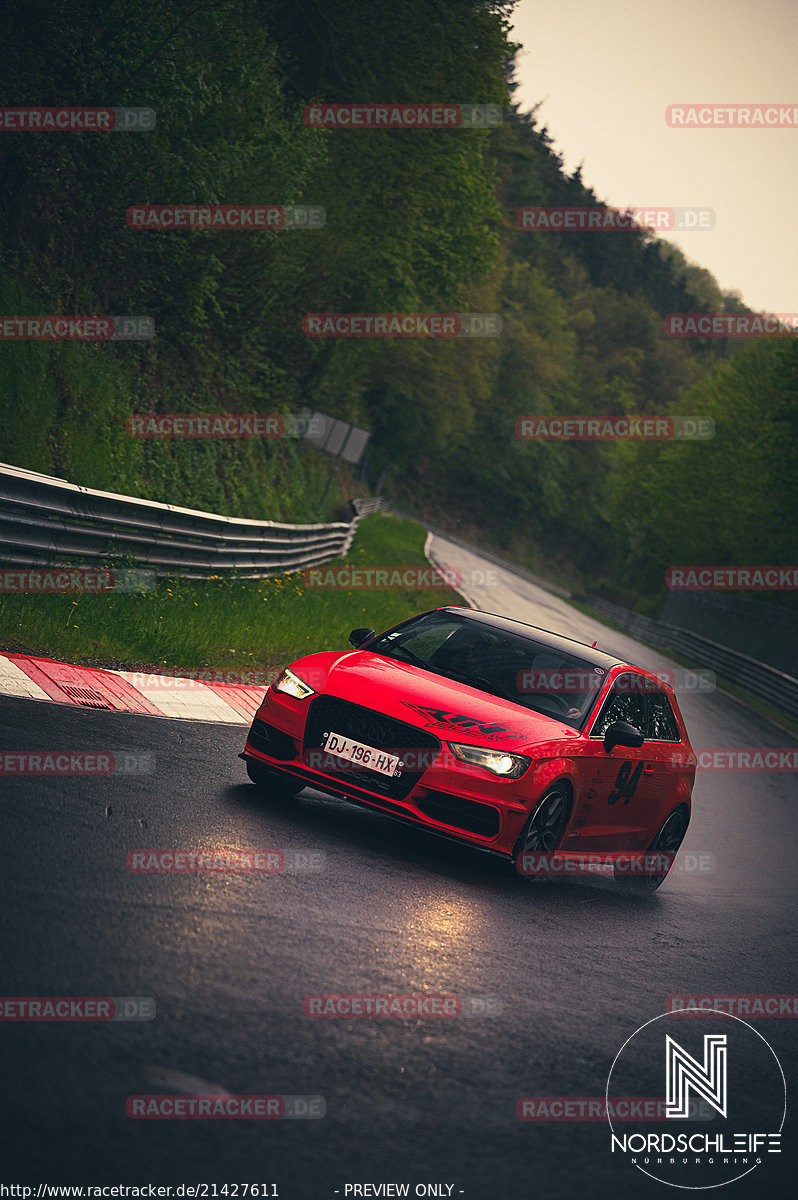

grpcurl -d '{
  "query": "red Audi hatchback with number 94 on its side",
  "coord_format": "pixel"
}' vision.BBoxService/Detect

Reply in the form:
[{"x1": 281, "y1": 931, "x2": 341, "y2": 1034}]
[{"x1": 240, "y1": 607, "x2": 696, "y2": 890}]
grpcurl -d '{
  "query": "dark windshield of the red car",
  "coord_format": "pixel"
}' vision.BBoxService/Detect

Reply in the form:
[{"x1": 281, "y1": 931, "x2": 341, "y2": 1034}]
[{"x1": 367, "y1": 612, "x2": 607, "y2": 728}]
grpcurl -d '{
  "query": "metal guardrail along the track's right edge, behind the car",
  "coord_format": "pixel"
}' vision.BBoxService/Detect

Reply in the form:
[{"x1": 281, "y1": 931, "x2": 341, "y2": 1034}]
[{"x1": 590, "y1": 600, "x2": 798, "y2": 720}]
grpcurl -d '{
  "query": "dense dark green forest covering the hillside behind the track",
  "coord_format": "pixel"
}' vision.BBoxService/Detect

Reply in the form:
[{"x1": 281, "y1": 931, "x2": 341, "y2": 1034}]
[{"x1": 0, "y1": 0, "x2": 798, "y2": 606}]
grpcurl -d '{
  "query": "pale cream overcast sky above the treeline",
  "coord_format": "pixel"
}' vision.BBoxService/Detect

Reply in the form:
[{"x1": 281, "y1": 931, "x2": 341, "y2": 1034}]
[{"x1": 511, "y1": 0, "x2": 798, "y2": 313}]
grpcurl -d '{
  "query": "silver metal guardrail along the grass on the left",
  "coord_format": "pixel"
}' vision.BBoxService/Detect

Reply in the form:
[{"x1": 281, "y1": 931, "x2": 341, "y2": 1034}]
[{"x1": 0, "y1": 463, "x2": 360, "y2": 580}]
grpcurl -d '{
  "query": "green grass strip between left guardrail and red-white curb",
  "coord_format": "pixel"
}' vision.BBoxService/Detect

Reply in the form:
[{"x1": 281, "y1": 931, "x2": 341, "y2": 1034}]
[{"x1": 0, "y1": 514, "x2": 463, "y2": 677}]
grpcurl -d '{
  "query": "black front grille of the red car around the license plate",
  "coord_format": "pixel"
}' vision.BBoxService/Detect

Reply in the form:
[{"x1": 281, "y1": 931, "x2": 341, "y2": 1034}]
[{"x1": 305, "y1": 696, "x2": 440, "y2": 800}]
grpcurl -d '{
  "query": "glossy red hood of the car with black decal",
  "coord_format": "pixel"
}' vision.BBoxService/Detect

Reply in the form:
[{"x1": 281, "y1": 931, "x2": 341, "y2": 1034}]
[{"x1": 290, "y1": 650, "x2": 580, "y2": 750}]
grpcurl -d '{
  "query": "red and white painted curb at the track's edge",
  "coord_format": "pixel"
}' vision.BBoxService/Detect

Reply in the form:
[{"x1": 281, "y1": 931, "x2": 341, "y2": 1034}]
[{"x1": 0, "y1": 654, "x2": 265, "y2": 725}]
